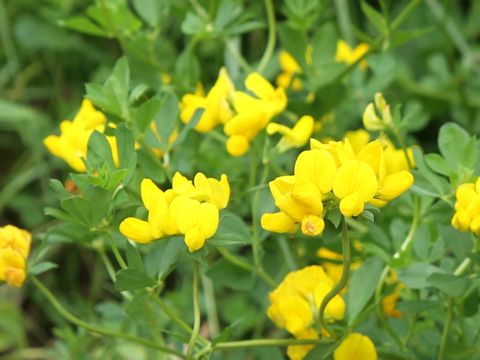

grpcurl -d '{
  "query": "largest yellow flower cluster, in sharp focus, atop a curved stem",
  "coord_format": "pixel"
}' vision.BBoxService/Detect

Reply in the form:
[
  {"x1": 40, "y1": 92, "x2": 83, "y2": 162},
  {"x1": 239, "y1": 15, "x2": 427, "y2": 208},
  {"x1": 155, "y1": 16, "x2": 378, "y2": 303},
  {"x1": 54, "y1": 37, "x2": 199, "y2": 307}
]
[{"x1": 261, "y1": 134, "x2": 413, "y2": 236}]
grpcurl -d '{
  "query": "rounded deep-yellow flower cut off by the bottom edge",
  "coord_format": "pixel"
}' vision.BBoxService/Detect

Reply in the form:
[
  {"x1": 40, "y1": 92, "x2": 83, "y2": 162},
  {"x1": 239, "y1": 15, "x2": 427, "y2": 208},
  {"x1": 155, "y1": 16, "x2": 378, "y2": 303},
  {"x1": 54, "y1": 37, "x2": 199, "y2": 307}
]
[{"x1": 333, "y1": 333, "x2": 377, "y2": 360}]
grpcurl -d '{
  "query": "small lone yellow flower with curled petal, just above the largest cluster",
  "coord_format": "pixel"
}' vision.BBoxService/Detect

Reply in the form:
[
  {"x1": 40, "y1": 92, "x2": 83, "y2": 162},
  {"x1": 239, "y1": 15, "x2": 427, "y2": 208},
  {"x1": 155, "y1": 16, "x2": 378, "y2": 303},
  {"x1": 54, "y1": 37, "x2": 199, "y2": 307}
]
[{"x1": 267, "y1": 115, "x2": 315, "y2": 152}]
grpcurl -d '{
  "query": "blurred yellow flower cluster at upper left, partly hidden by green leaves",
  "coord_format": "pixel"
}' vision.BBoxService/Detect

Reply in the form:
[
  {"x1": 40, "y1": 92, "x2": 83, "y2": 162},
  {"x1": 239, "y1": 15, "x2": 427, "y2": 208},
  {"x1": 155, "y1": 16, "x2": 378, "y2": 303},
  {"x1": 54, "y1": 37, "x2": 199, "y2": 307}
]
[{"x1": 43, "y1": 99, "x2": 118, "y2": 172}]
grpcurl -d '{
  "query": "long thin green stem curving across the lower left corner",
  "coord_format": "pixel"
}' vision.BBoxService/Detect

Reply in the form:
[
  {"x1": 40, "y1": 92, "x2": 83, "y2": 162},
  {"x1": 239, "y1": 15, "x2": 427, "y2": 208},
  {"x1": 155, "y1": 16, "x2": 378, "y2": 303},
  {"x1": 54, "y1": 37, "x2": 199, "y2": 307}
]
[{"x1": 30, "y1": 275, "x2": 185, "y2": 359}]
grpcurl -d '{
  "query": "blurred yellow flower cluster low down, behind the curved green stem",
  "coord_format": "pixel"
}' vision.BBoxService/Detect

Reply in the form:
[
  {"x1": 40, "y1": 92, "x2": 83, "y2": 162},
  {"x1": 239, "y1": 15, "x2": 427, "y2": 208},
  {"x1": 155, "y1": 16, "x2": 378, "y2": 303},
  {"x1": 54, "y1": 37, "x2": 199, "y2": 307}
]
[{"x1": 267, "y1": 265, "x2": 345, "y2": 359}]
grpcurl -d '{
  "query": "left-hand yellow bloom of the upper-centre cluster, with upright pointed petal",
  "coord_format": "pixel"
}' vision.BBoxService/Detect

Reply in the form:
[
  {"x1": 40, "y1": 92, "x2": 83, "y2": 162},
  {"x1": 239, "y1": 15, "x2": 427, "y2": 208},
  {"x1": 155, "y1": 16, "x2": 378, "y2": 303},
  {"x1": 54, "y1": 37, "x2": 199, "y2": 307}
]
[{"x1": 180, "y1": 68, "x2": 234, "y2": 133}]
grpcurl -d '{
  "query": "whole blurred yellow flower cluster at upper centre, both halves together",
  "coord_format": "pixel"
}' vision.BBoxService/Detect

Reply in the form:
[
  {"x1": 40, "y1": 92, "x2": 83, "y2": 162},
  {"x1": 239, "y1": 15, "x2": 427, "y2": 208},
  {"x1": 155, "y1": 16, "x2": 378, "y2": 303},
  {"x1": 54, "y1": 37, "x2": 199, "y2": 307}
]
[{"x1": 180, "y1": 69, "x2": 287, "y2": 156}]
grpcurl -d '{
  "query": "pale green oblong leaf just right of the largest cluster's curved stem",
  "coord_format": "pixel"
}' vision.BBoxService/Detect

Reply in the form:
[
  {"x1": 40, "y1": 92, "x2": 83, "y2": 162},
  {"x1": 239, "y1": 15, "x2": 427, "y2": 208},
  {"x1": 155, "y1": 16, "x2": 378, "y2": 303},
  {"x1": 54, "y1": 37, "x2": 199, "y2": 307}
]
[{"x1": 347, "y1": 258, "x2": 383, "y2": 324}]
